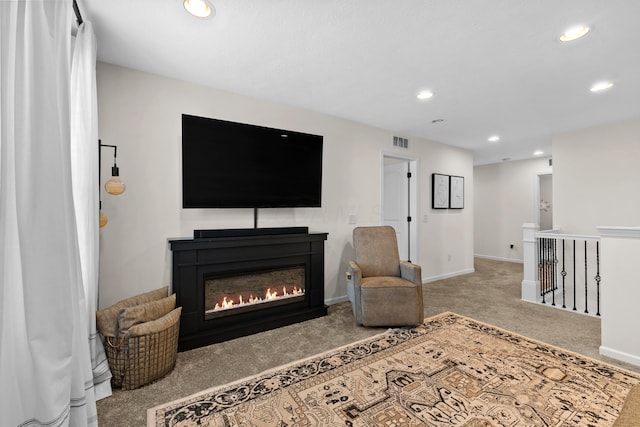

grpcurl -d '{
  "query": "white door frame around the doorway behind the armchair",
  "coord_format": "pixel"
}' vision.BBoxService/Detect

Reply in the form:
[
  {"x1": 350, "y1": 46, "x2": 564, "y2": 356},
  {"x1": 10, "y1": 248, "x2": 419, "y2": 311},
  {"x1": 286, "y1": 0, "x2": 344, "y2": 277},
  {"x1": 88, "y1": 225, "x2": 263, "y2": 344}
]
[{"x1": 380, "y1": 151, "x2": 420, "y2": 264}]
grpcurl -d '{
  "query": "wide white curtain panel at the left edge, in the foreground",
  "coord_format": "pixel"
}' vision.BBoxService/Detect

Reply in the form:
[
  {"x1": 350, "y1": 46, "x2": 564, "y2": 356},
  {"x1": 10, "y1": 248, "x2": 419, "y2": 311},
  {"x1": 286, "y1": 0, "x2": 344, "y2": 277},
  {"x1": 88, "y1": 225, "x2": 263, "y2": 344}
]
[{"x1": 0, "y1": 0, "x2": 97, "y2": 426}]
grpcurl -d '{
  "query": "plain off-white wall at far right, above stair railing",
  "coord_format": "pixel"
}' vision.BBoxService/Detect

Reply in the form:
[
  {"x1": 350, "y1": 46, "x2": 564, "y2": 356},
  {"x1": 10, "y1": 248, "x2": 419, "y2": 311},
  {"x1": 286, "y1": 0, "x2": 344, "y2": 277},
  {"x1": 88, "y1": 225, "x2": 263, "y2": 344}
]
[{"x1": 553, "y1": 119, "x2": 640, "y2": 234}]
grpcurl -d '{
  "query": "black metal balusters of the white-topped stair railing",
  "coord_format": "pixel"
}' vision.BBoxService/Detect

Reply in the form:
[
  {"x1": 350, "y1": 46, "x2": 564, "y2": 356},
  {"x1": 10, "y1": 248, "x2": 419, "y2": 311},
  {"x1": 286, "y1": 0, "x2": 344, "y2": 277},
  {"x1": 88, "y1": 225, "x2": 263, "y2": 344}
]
[{"x1": 536, "y1": 232, "x2": 602, "y2": 316}]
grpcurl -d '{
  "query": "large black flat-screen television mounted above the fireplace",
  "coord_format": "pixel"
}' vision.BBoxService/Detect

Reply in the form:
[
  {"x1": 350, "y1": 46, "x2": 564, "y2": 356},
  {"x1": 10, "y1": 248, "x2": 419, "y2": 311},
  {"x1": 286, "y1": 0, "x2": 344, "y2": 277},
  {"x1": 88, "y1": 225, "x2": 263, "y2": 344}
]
[{"x1": 182, "y1": 114, "x2": 322, "y2": 208}]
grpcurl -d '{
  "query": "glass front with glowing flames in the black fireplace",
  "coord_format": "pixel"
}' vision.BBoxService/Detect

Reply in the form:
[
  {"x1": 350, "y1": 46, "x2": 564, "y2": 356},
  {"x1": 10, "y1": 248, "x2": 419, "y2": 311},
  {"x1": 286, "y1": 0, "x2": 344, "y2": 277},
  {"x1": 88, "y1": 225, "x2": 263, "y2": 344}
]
[{"x1": 204, "y1": 265, "x2": 305, "y2": 320}]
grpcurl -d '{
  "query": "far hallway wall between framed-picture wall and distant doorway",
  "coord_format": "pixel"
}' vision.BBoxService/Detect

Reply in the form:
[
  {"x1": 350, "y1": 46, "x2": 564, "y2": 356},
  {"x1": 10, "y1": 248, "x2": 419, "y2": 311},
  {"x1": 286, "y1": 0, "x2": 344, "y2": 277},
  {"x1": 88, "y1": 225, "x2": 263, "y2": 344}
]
[{"x1": 473, "y1": 158, "x2": 555, "y2": 262}]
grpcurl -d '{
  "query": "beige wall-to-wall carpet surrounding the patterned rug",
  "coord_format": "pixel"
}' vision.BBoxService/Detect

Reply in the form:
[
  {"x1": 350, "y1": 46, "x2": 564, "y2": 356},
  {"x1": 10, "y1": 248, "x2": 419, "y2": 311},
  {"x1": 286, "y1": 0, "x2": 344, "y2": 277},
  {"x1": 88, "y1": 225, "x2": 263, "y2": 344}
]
[{"x1": 97, "y1": 258, "x2": 640, "y2": 427}]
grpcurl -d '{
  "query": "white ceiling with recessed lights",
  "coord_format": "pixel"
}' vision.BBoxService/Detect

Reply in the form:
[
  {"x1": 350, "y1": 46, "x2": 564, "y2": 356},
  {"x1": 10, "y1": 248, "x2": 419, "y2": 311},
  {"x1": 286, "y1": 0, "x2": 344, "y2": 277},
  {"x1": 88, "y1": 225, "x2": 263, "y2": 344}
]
[{"x1": 79, "y1": 0, "x2": 640, "y2": 164}]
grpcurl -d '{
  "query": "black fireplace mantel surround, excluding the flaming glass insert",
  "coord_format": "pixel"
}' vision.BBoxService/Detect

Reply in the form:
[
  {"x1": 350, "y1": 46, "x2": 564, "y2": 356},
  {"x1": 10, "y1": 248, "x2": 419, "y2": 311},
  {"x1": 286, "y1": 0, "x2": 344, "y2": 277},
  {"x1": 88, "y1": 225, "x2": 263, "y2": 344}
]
[{"x1": 169, "y1": 228, "x2": 327, "y2": 351}]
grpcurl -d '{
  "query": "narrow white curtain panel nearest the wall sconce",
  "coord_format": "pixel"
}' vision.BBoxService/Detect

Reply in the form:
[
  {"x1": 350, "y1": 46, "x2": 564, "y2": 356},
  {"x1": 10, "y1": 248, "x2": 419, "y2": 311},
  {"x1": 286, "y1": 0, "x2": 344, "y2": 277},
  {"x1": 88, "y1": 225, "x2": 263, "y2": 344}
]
[{"x1": 71, "y1": 19, "x2": 111, "y2": 399}]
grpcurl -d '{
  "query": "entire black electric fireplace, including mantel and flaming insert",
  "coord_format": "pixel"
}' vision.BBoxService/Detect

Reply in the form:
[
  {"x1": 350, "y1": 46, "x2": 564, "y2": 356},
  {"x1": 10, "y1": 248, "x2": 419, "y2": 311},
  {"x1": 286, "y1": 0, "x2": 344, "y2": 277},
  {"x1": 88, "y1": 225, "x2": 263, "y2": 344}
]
[{"x1": 169, "y1": 227, "x2": 327, "y2": 351}]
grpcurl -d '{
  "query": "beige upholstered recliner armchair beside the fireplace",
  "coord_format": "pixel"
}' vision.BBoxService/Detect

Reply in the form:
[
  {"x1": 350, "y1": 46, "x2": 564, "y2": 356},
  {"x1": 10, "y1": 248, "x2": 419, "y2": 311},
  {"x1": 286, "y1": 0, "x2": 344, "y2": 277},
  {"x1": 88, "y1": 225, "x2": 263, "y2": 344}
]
[{"x1": 349, "y1": 226, "x2": 424, "y2": 326}]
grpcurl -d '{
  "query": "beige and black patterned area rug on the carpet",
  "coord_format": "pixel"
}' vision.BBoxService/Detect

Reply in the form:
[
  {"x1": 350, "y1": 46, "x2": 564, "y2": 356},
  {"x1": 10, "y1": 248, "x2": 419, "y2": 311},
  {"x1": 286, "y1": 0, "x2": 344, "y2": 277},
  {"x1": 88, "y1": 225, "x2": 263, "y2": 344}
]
[{"x1": 147, "y1": 313, "x2": 640, "y2": 427}]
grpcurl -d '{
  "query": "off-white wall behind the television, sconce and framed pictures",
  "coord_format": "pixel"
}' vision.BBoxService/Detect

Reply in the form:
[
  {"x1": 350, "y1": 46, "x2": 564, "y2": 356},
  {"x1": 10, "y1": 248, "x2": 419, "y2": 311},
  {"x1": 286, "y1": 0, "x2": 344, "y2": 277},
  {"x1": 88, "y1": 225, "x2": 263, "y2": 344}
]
[{"x1": 97, "y1": 63, "x2": 476, "y2": 308}]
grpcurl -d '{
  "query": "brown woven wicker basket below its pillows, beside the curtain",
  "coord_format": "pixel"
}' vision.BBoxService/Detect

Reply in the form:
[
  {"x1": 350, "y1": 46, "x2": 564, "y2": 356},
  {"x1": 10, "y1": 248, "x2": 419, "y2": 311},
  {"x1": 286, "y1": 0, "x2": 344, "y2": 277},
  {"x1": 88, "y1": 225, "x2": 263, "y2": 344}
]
[{"x1": 105, "y1": 315, "x2": 180, "y2": 390}]
